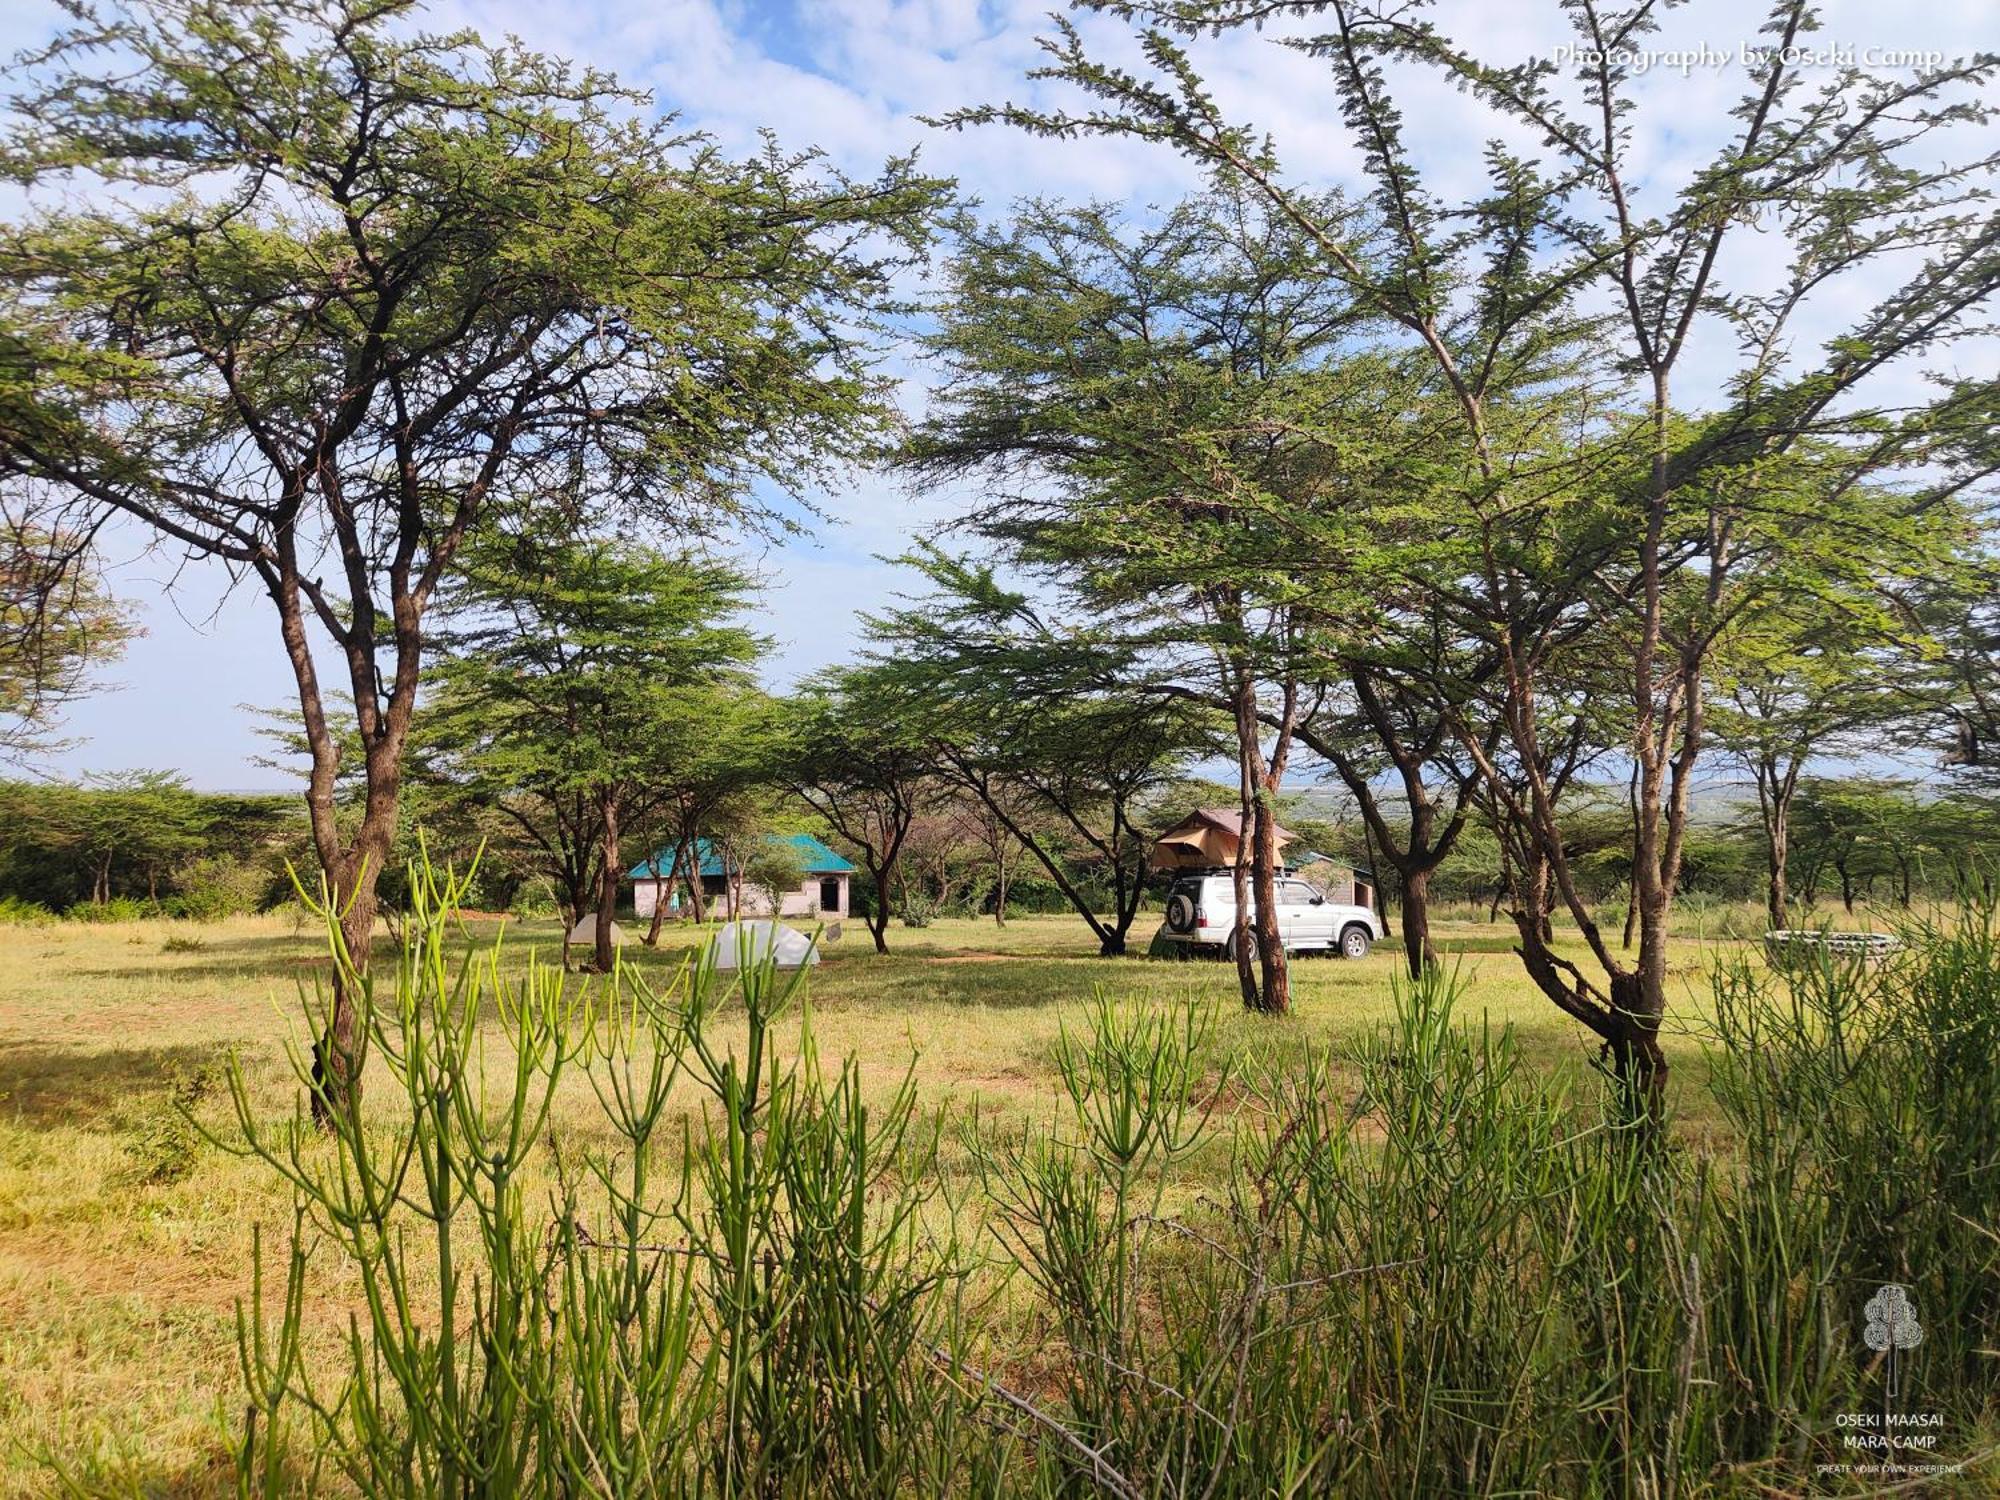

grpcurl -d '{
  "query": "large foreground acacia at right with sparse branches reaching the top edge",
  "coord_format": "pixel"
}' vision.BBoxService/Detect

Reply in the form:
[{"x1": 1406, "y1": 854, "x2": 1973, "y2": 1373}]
[{"x1": 952, "y1": 0, "x2": 2000, "y2": 1114}]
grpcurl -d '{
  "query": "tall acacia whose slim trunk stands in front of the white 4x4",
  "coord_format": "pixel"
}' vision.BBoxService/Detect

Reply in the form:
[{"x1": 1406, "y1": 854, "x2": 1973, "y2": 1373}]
[{"x1": 904, "y1": 192, "x2": 1392, "y2": 1012}]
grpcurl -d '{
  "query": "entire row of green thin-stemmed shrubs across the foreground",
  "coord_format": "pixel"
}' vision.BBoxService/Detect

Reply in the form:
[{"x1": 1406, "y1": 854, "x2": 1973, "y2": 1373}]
[{"x1": 228, "y1": 870, "x2": 2000, "y2": 1500}]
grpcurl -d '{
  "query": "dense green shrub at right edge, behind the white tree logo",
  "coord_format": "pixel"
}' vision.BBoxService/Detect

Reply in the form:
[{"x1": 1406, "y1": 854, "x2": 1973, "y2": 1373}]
[{"x1": 1710, "y1": 904, "x2": 2000, "y2": 1460}]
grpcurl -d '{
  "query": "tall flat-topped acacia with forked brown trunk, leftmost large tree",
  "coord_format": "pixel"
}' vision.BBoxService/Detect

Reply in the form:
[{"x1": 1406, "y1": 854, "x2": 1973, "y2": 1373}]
[{"x1": 0, "y1": 0, "x2": 938, "y2": 1108}]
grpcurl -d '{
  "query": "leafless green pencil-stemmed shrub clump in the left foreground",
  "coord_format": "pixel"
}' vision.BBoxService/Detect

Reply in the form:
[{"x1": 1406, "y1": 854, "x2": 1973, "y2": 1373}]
[{"x1": 218, "y1": 852, "x2": 964, "y2": 1496}]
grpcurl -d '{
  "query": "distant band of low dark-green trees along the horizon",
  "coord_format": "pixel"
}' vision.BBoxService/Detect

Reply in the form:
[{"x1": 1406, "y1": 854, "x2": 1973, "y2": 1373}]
[{"x1": 0, "y1": 772, "x2": 2000, "y2": 936}]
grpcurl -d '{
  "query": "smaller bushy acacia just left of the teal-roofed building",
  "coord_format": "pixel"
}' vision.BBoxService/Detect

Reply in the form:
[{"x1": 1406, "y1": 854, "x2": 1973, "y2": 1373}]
[{"x1": 428, "y1": 534, "x2": 764, "y2": 972}]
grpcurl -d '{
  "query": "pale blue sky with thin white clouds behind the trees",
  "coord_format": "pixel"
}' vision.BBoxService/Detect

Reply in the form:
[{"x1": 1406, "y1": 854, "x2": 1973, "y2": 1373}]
[{"x1": 0, "y1": 0, "x2": 1996, "y2": 788}]
